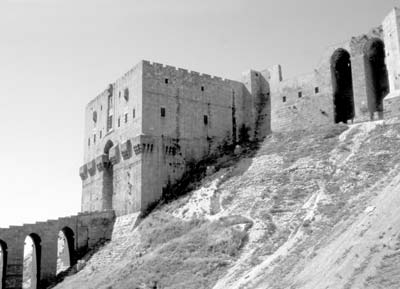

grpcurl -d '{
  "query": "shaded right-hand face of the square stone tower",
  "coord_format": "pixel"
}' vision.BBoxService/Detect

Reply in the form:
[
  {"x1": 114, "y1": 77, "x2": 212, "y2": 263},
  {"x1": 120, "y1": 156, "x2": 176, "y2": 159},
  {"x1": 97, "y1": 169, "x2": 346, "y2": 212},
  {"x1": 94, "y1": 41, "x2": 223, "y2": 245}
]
[{"x1": 142, "y1": 61, "x2": 253, "y2": 207}]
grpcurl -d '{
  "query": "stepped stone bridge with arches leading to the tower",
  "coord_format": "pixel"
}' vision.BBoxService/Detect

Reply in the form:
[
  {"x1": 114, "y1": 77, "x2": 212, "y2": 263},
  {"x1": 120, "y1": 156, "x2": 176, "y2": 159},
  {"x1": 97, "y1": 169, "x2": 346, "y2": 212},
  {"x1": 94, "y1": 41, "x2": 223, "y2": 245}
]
[{"x1": 0, "y1": 211, "x2": 115, "y2": 289}]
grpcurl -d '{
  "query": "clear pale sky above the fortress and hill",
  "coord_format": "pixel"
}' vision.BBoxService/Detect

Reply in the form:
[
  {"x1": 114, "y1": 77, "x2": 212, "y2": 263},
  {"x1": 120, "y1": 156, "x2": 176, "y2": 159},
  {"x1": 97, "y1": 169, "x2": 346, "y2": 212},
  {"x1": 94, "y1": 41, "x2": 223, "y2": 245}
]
[{"x1": 0, "y1": 0, "x2": 400, "y2": 227}]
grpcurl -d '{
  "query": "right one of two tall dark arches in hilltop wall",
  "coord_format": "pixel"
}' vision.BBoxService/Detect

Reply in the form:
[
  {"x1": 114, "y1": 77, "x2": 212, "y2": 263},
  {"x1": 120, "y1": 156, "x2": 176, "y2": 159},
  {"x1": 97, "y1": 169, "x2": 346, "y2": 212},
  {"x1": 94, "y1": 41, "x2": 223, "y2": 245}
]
[{"x1": 364, "y1": 38, "x2": 389, "y2": 120}]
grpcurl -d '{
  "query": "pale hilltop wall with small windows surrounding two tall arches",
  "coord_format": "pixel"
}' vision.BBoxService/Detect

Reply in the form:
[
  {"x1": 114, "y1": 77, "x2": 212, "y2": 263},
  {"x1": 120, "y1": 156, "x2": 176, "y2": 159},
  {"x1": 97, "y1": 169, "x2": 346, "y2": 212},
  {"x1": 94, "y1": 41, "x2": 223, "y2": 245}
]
[{"x1": 262, "y1": 27, "x2": 388, "y2": 131}]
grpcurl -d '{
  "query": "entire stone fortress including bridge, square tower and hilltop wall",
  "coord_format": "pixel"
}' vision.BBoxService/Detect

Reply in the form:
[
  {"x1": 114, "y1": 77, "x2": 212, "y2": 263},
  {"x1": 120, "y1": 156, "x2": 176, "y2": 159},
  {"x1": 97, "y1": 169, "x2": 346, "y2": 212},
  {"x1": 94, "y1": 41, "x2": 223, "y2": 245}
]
[{"x1": 0, "y1": 8, "x2": 400, "y2": 289}]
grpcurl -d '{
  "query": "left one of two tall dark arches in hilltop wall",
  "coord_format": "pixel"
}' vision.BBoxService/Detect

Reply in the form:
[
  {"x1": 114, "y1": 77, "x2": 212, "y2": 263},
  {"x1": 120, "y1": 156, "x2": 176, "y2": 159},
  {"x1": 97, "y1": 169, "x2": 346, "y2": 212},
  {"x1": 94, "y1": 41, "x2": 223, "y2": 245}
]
[{"x1": 331, "y1": 48, "x2": 354, "y2": 123}]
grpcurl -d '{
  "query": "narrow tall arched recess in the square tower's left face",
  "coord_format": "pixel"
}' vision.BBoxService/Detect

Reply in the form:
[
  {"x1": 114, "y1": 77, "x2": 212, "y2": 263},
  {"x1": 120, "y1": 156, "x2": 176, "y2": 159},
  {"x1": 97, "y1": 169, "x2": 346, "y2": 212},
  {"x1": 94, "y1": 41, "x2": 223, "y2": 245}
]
[{"x1": 102, "y1": 140, "x2": 114, "y2": 210}]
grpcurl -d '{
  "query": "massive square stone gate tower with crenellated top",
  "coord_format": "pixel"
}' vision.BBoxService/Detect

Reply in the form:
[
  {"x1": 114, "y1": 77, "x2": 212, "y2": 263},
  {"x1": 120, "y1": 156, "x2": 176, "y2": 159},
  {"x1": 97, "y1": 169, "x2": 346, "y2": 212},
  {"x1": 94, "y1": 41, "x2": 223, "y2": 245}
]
[{"x1": 80, "y1": 61, "x2": 270, "y2": 215}]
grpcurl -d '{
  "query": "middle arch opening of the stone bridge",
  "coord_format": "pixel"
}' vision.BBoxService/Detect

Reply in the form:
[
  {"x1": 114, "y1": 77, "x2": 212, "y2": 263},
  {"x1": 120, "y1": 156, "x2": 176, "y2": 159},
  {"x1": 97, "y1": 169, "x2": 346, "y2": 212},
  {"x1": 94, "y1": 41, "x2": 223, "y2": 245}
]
[{"x1": 22, "y1": 233, "x2": 42, "y2": 289}]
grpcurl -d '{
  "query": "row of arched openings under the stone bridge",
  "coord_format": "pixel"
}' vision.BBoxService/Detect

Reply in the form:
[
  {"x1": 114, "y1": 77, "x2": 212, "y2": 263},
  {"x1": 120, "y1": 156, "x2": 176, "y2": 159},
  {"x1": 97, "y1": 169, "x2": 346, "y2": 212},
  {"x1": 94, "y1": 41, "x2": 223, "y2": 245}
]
[{"x1": 0, "y1": 227, "x2": 76, "y2": 289}]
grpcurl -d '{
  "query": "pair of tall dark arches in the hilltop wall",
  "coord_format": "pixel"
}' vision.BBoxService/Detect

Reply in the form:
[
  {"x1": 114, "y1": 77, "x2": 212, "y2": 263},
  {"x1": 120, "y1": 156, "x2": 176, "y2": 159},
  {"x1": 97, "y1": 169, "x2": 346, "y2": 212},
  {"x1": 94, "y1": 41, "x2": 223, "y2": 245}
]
[{"x1": 330, "y1": 38, "x2": 389, "y2": 123}]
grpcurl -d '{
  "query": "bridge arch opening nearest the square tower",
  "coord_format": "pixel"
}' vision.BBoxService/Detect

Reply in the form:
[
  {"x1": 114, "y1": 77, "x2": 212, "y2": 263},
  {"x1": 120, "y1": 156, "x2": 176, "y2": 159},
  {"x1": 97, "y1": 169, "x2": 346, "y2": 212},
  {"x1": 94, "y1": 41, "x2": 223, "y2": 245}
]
[{"x1": 56, "y1": 227, "x2": 76, "y2": 275}]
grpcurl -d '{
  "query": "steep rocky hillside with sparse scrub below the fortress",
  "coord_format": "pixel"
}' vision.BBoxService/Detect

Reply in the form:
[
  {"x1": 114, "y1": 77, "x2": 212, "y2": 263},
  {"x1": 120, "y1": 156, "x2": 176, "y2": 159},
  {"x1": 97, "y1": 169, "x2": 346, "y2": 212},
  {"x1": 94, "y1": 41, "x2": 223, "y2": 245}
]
[{"x1": 55, "y1": 120, "x2": 400, "y2": 289}]
